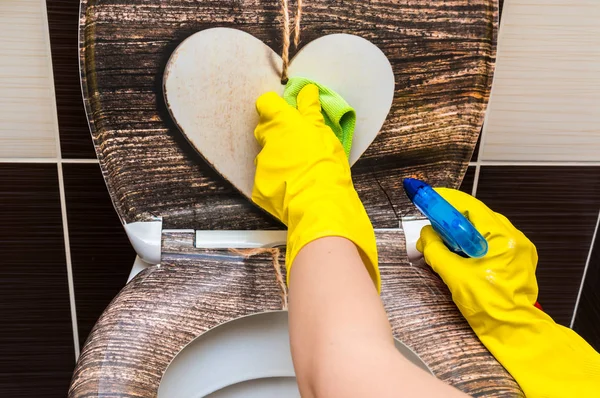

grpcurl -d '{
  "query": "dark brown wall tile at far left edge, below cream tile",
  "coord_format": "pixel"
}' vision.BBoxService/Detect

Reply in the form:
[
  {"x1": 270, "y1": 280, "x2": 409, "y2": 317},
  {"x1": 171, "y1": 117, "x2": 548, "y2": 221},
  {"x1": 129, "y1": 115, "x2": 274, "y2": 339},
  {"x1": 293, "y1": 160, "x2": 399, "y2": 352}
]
[{"x1": 0, "y1": 164, "x2": 75, "y2": 398}]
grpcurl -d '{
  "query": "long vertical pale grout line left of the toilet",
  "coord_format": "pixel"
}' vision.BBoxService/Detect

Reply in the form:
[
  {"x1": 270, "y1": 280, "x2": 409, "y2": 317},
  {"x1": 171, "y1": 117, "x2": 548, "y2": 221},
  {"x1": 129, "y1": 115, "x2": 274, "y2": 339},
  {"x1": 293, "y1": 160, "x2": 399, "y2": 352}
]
[{"x1": 40, "y1": 0, "x2": 80, "y2": 362}]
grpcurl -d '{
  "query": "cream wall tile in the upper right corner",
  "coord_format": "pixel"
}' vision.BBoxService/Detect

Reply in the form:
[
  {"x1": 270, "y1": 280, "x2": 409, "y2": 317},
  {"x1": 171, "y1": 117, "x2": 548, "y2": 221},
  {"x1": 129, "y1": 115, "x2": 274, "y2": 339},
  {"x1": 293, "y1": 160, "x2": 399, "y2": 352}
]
[{"x1": 480, "y1": 0, "x2": 600, "y2": 162}]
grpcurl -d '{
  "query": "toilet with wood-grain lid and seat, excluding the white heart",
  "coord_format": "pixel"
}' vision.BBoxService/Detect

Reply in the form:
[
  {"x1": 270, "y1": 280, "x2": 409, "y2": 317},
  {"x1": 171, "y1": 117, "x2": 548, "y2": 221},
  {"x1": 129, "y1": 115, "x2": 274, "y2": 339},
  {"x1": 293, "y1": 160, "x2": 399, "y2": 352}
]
[{"x1": 69, "y1": 0, "x2": 523, "y2": 398}]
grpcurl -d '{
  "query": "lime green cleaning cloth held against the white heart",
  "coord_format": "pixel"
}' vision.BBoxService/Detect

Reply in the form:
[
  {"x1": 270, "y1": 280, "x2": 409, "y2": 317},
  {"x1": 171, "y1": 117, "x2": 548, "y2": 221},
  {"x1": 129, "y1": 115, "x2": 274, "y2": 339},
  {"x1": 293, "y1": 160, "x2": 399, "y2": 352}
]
[{"x1": 283, "y1": 77, "x2": 356, "y2": 158}]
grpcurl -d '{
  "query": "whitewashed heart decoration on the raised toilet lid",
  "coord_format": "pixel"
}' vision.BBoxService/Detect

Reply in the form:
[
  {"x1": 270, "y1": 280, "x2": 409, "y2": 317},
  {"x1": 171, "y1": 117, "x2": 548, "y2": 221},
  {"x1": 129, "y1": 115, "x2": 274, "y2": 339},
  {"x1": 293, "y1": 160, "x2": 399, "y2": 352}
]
[{"x1": 163, "y1": 28, "x2": 394, "y2": 198}]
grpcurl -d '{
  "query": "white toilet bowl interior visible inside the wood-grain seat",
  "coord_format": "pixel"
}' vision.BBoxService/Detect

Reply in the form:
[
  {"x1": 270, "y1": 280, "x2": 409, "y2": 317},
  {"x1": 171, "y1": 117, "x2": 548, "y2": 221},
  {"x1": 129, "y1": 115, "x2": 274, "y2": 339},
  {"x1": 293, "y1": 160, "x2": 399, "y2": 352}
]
[{"x1": 158, "y1": 311, "x2": 431, "y2": 398}]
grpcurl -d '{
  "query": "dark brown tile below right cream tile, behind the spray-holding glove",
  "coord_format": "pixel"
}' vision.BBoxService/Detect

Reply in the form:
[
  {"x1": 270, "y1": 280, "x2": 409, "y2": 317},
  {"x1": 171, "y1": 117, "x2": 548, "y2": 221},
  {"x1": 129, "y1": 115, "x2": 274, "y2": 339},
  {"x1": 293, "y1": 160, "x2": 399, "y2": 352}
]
[{"x1": 477, "y1": 166, "x2": 600, "y2": 325}]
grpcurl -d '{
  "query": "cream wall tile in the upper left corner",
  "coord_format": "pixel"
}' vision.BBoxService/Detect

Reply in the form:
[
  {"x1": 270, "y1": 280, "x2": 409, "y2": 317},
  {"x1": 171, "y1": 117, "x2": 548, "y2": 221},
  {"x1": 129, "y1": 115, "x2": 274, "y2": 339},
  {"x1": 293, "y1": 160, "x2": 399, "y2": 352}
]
[{"x1": 0, "y1": 0, "x2": 58, "y2": 158}]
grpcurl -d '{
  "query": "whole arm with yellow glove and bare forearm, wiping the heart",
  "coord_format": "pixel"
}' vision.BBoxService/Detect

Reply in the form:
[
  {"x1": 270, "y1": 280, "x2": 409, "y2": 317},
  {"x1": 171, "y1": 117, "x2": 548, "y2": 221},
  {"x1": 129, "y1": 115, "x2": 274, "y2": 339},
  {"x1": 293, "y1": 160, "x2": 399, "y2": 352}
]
[{"x1": 252, "y1": 85, "x2": 464, "y2": 398}]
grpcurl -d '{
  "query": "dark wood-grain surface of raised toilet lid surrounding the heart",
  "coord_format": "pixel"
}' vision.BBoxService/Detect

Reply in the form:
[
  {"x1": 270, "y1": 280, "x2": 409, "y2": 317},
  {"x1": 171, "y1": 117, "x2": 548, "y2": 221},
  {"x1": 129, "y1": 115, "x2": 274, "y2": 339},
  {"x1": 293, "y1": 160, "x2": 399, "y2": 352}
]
[{"x1": 80, "y1": 0, "x2": 498, "y2": 229}]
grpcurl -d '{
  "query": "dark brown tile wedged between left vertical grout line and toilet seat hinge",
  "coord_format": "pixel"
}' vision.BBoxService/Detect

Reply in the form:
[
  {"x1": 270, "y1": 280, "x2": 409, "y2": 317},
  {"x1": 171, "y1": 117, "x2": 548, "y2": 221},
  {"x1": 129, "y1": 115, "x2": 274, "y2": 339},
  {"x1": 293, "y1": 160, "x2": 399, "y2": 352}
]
[{"x1": 63, "y1": 164, "x2": 135, "y2": 346}]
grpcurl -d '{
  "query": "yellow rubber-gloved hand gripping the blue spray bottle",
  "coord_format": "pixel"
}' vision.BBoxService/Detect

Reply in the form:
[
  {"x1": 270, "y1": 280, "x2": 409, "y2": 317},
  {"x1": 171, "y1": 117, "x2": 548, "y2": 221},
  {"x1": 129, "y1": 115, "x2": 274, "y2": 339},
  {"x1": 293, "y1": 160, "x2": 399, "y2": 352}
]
[{"x1": 417, "y1": 188, "x2": 600, "y2": 398}]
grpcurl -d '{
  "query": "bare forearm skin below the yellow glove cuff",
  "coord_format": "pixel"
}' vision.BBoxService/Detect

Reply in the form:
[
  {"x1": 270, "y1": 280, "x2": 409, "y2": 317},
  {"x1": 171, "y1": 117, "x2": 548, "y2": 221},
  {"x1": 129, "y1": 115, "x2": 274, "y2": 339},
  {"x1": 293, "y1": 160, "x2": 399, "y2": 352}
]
[{"x1": 290, "y1": 237, "x2": 464, "y2": 397}]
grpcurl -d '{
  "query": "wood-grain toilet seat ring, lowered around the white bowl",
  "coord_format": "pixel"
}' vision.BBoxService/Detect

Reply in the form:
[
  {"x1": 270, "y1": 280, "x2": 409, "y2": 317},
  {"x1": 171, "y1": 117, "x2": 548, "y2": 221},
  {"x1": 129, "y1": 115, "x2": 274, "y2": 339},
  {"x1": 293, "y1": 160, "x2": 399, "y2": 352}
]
[{"x1": 69, "y1": 231, "x2": 523, "y2": 398}]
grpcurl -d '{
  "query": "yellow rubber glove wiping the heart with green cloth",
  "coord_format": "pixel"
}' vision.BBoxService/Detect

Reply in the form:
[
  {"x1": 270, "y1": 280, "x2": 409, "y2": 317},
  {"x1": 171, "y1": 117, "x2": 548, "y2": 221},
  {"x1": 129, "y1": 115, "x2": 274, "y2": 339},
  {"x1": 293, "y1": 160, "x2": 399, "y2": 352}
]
[{"x1": 252, "y1": 84, "x2": 381, "y2": 291}]
